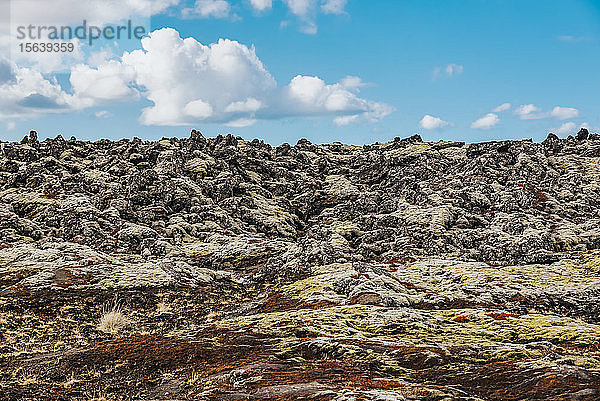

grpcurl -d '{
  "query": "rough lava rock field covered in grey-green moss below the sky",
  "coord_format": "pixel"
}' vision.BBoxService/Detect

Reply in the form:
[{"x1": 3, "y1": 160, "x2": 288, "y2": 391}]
[{"x1": 0, "y1": 130, "x2": 600, "y2": 401}]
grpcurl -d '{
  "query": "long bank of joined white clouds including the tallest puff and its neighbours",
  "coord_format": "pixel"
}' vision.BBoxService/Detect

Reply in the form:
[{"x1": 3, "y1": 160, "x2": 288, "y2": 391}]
[{"x1": 71, "y1": 28, "x2": 393, "y2": 127}]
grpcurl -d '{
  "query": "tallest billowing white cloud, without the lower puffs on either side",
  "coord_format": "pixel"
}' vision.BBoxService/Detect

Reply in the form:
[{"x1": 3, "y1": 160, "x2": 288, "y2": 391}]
[{"x1": 123, "y1": 28, "x2": 277, "y2": 125}]
